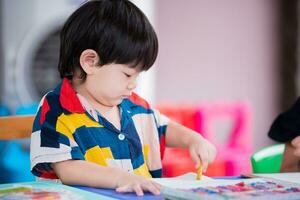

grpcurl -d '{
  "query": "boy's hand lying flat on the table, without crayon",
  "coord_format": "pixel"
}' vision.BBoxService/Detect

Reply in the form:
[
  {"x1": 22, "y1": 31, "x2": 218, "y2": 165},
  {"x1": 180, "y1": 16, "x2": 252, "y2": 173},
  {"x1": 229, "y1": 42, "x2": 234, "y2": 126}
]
[{"x1": 116, "y1": 173, "x2": 161, "y2": 196}]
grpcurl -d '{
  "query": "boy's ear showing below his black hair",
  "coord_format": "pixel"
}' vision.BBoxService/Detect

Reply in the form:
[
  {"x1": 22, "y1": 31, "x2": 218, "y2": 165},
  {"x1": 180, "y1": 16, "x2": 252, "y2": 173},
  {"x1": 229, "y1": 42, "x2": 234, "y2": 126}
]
[{"x1": 79, "y1": 49, "x2": 100, "y2": 74}]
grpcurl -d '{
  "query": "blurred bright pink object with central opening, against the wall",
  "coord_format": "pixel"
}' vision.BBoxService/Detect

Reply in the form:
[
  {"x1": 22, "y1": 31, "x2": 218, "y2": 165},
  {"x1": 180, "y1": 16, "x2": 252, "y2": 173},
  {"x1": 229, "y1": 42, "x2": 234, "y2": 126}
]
[{"x1": 196, "y1": 102, "x2": 253, "y2": 175}]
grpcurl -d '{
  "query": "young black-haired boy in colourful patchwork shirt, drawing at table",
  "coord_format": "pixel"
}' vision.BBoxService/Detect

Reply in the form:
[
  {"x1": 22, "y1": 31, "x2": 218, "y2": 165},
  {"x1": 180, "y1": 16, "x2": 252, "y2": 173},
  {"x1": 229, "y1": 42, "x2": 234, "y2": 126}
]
[{"x1": 31, "y1": 0, "x2": 216, "y2": 195}]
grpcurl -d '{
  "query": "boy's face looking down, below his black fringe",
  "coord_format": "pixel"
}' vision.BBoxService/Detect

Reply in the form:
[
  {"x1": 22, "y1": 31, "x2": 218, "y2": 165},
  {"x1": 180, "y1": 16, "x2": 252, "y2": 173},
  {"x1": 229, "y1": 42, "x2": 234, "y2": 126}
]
[{"x1": 84, "y1": 63, "x2": 140, "y2": 107}]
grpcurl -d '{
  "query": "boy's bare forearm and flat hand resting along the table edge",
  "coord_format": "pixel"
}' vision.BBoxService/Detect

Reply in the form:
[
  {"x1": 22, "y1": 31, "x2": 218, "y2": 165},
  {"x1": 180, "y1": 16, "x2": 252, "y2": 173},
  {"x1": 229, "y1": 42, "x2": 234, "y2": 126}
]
[{"x1": 52, "y1": 160, "x2": 160, "y2": 196}]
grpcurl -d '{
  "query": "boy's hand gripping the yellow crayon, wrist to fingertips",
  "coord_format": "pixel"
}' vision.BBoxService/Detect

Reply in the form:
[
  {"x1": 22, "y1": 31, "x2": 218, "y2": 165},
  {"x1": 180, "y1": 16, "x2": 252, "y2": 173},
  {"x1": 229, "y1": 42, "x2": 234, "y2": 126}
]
[{"x1": 189, "y1": 136, "x2": 217, "y2": 172}]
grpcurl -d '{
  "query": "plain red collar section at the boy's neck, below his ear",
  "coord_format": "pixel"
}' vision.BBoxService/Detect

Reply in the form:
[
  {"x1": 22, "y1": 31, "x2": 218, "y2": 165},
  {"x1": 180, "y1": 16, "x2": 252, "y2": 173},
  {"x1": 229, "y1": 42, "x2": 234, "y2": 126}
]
[{"x1": 59, "y1": 78, "x2": 85, "y2": 113}]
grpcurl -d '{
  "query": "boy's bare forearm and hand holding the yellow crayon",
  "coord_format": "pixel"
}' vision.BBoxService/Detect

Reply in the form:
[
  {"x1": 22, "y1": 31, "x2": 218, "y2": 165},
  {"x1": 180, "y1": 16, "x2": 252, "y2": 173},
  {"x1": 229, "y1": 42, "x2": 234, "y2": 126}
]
[{"x1": 166, "y1": 120, "x2": 217, "y2": 172}]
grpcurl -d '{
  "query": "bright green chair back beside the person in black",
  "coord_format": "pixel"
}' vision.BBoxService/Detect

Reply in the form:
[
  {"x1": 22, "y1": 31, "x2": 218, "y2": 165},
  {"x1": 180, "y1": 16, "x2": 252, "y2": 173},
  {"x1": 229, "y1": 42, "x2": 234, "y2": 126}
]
[{"x1": 251, "y1": 144, "x2": 285, "y2": 173}]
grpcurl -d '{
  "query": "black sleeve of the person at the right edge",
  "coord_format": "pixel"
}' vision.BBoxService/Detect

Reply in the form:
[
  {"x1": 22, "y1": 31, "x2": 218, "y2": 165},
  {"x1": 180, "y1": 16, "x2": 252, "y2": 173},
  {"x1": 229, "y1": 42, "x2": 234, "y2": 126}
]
[{"x1": 268, "y1": 98, "x2": 300, "y2": 142}]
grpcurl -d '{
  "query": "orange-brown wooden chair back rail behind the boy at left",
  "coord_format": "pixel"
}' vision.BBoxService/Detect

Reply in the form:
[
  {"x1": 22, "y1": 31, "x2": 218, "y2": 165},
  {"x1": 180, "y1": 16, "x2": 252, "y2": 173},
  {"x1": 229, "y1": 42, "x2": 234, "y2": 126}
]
[{"x1": 0, "y1": 115, "x2": 34, "y2": 140}]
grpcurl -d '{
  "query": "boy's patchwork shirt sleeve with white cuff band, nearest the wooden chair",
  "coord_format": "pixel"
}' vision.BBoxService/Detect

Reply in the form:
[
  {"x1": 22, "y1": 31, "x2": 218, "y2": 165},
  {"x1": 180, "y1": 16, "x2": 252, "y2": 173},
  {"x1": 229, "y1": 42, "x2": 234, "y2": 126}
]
[{"x1": 30, "y1": 96, "x2": 84, "y2": 179}]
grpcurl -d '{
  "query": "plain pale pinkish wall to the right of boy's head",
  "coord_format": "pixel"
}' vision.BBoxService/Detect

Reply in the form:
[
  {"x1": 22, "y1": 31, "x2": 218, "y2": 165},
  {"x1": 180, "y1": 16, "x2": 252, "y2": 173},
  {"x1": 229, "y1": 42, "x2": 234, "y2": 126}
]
[{"x1": 156, "y1": 0, "x2": 278, "y2": 149}]
